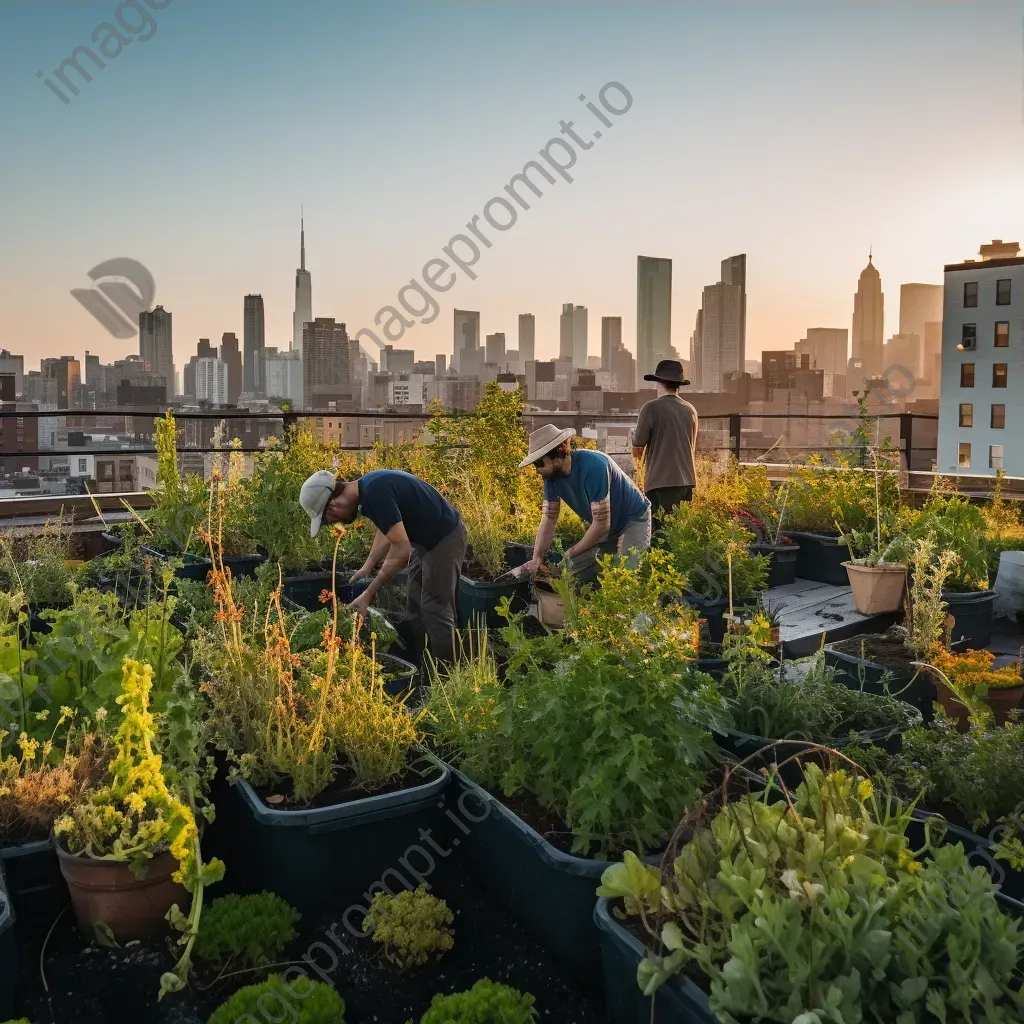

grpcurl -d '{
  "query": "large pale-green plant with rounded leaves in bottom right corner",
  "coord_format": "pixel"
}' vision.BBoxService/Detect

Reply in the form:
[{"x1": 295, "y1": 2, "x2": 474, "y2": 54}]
[{"x1": 598, "y1": 764, "x2": 1024, "y2": 1024}]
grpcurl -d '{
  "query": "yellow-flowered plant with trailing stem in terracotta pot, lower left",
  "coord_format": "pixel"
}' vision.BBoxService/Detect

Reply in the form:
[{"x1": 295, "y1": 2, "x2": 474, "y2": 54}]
[{"x1": 53, "y1": 658, "x2": 224, "y2": 991}]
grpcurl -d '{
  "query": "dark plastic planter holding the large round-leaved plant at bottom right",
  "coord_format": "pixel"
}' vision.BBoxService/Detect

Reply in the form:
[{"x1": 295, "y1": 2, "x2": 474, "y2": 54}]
[{"x1": 594, "y1": 899, "x2": 718, "y2": 1024}]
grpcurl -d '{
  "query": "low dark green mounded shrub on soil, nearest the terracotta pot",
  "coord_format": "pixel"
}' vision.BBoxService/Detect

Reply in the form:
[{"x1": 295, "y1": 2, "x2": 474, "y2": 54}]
[{"x1": 195, "y1": 892, "x2": 299, "y2": 970}]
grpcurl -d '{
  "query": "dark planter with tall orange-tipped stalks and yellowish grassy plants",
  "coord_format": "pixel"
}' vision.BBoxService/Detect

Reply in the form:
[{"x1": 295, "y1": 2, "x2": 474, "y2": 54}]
[{"x1": 194, "y1": 512, "x2": 449, "y2": 913}]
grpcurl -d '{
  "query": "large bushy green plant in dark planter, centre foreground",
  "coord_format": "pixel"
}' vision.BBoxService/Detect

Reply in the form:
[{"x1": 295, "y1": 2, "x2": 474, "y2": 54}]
[{"x1": 424, "y1": 551, "x2": 724, "y2": 974}]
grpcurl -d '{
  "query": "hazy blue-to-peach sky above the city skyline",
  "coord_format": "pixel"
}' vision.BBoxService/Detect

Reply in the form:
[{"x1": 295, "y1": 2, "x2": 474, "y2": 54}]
[{"x1": 0, "y1": 0, "x2": 1024, "y2": 370}]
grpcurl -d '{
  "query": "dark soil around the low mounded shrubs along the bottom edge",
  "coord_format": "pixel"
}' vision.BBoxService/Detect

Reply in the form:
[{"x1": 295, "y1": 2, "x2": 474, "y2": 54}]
[{"x1": 18, "y1": 856, "x2": 604, "y2": 1024}]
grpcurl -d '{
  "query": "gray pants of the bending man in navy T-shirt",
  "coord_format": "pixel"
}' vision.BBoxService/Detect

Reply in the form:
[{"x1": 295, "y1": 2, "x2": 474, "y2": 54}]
[{"x1": 409, "y1": 520, "x2": 466, "y2": 662}]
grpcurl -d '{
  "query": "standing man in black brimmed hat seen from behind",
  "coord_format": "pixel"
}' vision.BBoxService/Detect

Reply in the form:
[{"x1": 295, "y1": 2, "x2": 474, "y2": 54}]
[{"x1": 633, "y1": 359, "x2": 697, "y2": 518}]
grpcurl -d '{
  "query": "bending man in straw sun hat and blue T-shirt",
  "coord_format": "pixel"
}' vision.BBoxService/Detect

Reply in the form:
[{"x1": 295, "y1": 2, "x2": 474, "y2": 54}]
[{"x1": 519, "y1": 423, "x2": 650, "y2": 583}]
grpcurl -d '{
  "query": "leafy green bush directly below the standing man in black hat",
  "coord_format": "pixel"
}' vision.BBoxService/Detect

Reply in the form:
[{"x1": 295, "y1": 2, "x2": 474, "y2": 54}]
[{"x1": 660, "y1": 502, "x2": 769, "y2": 598}]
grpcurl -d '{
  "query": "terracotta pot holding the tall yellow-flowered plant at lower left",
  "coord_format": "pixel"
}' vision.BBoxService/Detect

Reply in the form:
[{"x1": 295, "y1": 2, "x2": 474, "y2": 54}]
[{"x1": 54, "y1": 842, "x2": 191, "y2": 943}]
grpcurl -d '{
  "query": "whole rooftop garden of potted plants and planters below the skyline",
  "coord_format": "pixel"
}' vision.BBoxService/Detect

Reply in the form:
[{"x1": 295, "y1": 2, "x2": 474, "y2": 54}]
[{"x1": 0, "y1": 387, "x2": 1024, "y2": 1024}]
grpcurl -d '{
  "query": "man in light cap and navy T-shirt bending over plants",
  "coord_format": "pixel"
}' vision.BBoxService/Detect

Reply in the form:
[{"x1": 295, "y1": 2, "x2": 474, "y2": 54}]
[{"x1": 299, "y1": 469, "x2": 466, "y2": 662}]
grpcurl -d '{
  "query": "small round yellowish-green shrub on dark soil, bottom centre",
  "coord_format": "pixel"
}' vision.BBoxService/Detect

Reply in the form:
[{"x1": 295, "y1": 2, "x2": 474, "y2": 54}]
[{"x1": 362, "y1": 886, "x2": 455, "y2": 968}]
